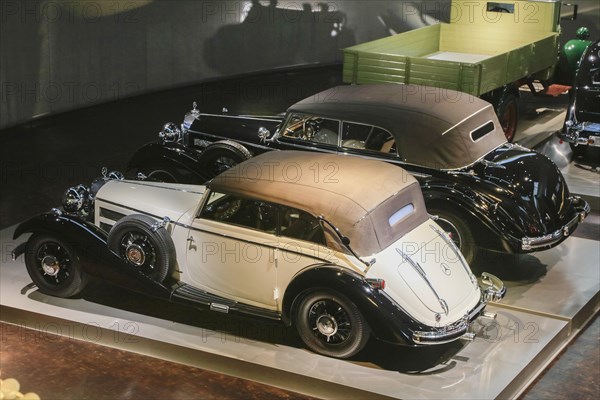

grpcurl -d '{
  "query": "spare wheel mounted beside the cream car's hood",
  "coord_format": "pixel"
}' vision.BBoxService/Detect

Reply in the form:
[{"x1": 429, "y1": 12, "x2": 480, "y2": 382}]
[{"x1": 108, "y1": 214, "x2": 176, "y2": 283}]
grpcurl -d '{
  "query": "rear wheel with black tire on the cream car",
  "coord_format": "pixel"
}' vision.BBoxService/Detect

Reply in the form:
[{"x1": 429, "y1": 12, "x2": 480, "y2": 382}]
[{"x1": 295, "y1": 290, "x2": 370, "y2": 358}]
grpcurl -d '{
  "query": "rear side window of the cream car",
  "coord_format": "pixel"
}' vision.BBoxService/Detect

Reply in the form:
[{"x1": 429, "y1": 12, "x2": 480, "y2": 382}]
[{"x1": 280, "y1": 206, "x2": 325, "y2": 245}]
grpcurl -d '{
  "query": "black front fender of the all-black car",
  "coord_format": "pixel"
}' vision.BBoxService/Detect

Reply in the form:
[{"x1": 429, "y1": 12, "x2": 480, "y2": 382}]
[{"x1": 127, "y1": 142, "x2": 210, "y2": 184}]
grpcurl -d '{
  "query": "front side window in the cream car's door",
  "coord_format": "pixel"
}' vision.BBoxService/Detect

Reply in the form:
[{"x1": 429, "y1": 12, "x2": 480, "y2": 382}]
[{"x1": 200, "y1": 192, "x2": 277, "y2": 234}]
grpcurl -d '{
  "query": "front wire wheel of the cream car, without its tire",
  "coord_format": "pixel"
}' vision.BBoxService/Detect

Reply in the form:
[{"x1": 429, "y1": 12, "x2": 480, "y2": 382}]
[{"x1": 35, "y1": 241, "x2": 72, "y2": 285}]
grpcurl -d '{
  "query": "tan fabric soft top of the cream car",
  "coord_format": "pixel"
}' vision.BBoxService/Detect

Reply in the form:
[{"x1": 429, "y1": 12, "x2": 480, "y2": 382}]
[{"x1": 208, "y1": 151, "x2": 428, "y2": 256}]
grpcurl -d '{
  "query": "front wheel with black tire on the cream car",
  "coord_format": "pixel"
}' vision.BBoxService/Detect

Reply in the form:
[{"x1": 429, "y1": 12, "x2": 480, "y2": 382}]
[{"x1": 25, "y1": 234, "x2": 88, "y2": 298}]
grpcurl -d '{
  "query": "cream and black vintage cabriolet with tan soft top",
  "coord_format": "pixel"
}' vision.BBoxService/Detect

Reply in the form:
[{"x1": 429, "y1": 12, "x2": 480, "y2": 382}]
[{"x1": 13, "y1": 152, "x2": 505, "y2": 358}]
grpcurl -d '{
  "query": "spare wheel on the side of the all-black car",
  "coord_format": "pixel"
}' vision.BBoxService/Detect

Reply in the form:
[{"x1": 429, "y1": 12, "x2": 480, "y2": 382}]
[{"x1": 200, "y1": 140, "x2": 252, "y2": 179}]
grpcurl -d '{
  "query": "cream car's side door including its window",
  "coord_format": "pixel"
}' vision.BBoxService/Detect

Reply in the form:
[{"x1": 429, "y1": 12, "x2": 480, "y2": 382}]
[{"x1": 186, "y1": 192, "x2": 277, "y2": 309}]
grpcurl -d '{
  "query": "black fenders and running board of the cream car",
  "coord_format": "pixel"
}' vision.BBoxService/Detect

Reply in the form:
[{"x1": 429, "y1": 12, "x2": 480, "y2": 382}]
[{"x1": 13, "y1": 210, "x2": 474, "y2": 346}]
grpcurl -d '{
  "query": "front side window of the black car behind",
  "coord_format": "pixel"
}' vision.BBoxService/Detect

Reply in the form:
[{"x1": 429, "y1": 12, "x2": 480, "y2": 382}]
[{"x1": 282, "y1": 114, "x2": 340, "y2": 146}]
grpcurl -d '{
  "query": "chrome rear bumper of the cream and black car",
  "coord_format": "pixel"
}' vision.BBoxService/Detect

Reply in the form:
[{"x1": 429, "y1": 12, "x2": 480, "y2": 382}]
[{"x1": 412, "y1": 272, "x2": 506, "y2": 345}]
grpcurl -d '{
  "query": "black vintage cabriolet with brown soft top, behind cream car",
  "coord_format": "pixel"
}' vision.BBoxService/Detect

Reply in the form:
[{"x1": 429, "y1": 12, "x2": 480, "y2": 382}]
[{"x1": 129, "y1": 84, "x2": 589, "y2": 263}]
